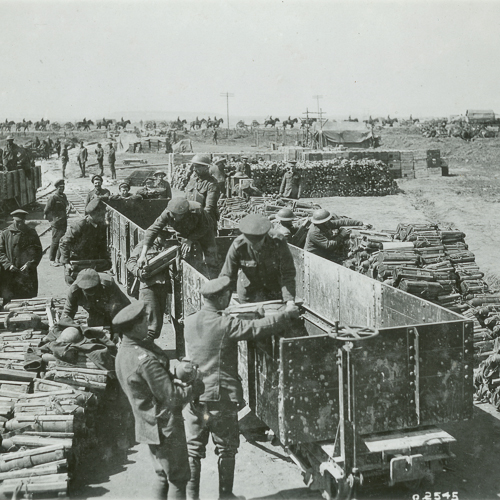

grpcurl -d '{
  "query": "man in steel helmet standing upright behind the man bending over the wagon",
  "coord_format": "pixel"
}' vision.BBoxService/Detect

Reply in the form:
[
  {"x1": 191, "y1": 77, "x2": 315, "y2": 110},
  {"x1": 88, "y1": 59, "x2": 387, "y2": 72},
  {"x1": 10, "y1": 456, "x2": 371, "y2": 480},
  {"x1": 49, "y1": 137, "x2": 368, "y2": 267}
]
[{"x1": 186, "y1": 154, "x2": 220, "y2": 227}]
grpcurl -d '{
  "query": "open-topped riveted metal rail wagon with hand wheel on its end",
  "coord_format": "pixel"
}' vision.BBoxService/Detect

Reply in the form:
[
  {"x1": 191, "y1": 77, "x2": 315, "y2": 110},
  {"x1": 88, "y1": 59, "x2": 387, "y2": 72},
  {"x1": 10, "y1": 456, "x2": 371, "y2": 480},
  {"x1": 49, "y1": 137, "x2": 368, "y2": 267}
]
[{"x1": 105, "y1": 200, "x2": 473, "y2": 499}]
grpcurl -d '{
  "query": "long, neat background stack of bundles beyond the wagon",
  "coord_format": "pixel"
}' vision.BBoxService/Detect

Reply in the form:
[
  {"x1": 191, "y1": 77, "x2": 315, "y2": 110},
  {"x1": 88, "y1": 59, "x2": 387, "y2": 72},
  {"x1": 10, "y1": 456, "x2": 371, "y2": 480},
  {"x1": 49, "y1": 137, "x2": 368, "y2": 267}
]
[{"x1": 172, "y1": 159, "x2": 398, "y2": 198}]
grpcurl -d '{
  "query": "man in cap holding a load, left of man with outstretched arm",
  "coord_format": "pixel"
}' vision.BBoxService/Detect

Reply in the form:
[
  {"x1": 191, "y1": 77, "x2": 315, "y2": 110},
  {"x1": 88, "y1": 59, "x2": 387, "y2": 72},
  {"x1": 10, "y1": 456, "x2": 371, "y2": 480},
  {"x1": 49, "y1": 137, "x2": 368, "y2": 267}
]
[{"x1": 113, "y1": 301, "x2": 196, "y2": 499}]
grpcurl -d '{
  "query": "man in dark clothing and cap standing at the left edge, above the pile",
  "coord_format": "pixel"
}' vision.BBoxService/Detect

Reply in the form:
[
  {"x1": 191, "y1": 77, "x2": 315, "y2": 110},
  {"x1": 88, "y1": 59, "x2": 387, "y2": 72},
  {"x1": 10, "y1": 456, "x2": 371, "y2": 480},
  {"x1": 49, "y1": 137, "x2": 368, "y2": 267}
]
[{"x1": 0, "y1": 210, "x2": 43, "y2": 303}]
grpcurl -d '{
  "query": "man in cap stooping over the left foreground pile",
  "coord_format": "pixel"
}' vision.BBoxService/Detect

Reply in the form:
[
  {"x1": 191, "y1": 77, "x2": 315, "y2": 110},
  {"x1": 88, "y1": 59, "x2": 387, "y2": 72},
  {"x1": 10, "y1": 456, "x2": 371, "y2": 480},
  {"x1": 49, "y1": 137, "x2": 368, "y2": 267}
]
[{"x1": 62, "y1": 269, "x2": 130, "y2": 327}]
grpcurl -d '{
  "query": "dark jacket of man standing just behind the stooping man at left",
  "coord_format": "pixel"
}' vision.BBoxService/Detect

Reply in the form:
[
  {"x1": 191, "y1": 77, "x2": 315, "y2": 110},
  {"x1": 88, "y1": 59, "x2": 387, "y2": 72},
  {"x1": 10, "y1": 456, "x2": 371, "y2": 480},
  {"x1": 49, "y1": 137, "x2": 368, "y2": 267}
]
[{"x1": 59, "y1": 216, "x2": 109, "y2": 264}]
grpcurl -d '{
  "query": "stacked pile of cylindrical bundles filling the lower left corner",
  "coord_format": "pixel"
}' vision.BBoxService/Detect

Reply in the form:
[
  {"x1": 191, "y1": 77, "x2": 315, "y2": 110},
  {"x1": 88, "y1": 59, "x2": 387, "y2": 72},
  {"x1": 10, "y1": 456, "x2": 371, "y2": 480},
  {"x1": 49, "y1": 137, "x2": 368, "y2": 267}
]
[{"x1": 0, "y1": 298, "x2": 116, "y2": 497}]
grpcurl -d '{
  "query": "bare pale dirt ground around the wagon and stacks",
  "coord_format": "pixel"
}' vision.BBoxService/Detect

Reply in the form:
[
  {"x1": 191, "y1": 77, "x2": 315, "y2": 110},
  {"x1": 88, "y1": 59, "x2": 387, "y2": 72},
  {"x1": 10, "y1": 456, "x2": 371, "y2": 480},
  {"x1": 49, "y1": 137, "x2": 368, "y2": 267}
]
[{"x1": 0, "y1": 128, "x2": 500, "y2": 500}]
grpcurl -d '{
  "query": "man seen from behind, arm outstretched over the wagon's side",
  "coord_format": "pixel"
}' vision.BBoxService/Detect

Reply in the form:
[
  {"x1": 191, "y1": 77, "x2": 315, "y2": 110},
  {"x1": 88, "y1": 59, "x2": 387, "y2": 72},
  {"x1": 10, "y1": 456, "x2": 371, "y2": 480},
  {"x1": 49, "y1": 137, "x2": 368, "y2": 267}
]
[{"x1": 184, "y1": 276, "x2": 299, "y2": 500}]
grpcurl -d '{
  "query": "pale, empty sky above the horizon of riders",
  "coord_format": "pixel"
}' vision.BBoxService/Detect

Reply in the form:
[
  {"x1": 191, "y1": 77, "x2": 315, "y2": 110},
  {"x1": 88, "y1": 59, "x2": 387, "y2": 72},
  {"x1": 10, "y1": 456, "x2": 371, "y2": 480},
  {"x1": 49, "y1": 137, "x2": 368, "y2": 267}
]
[{"x1": 0, "y1": 0, "x2": 500, "y2": 121}]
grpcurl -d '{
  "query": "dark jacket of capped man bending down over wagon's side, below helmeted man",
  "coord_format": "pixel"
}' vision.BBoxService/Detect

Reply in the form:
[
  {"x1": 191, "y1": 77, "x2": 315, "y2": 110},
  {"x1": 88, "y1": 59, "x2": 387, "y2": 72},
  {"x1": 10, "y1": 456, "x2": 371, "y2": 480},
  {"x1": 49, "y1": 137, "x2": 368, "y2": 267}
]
[{"x1": 144, "y1": 210, "x2": 215, "y2": 254}]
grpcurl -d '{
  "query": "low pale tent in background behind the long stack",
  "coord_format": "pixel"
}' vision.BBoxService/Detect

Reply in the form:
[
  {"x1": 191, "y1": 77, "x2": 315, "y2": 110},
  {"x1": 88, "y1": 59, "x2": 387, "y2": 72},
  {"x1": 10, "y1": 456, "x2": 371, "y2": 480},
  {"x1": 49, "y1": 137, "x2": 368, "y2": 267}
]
[{"x1": 311, "y1": 121, "x2": 377, "y2": 149}]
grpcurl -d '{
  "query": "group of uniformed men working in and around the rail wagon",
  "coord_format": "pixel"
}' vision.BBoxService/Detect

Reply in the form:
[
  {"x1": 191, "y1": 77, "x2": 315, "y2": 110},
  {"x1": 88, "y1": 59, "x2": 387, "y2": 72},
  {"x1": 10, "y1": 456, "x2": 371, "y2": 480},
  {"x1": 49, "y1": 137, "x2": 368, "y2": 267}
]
[{"x1": 0, "y1": 149, "x2": 368, "y2": 500}]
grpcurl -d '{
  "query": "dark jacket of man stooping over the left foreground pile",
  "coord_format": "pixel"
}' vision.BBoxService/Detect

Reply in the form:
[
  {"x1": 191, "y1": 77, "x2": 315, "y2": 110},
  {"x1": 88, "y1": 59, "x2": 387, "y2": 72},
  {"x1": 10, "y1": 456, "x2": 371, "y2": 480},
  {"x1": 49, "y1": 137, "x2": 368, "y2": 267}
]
[{"x1": 62, "y1": 273, "x2": 130, "y2": 326}]
